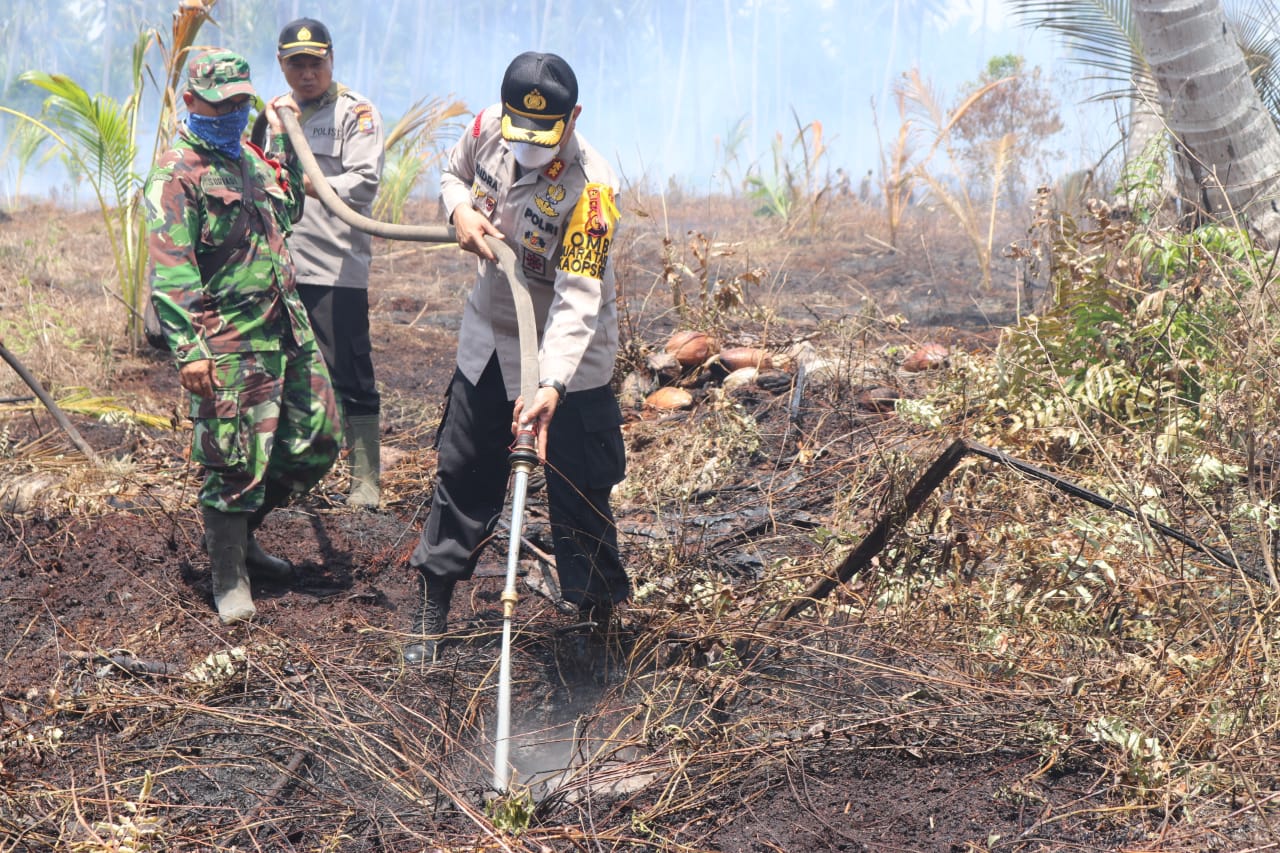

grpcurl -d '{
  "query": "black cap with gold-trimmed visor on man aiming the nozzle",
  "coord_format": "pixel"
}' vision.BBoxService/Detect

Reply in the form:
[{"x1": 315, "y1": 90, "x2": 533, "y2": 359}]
[{"x1": 502, "y1": 51, "x2": 577, "y2": 149}]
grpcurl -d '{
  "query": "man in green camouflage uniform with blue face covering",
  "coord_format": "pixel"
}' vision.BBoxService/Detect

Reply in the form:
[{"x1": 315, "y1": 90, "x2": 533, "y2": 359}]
[{"x1": 143, "y1": 49, "x2": 340, "y2": 624}]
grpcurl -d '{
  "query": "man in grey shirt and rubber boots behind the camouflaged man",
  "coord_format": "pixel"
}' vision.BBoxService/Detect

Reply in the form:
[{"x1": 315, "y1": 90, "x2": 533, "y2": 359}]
[{"x1": 276, "y1": 18, "x2": 385, "y2": 507}]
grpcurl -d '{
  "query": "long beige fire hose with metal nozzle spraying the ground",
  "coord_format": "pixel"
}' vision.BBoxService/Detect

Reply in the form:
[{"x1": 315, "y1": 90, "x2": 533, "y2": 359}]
[{"x1": 277, "y1": 109, "x2": 539, "y2": 794}]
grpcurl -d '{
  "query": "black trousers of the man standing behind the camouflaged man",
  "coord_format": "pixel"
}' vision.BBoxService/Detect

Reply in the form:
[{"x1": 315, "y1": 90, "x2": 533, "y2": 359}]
[{"x1": 298, "y1": 284, "x2": 381, "y2": 418}]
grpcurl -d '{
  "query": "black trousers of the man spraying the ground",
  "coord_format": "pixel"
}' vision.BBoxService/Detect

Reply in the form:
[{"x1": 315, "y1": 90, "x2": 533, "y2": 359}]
[{"x1": 410, "y1": 357, "x2": 631, "y2": 605}]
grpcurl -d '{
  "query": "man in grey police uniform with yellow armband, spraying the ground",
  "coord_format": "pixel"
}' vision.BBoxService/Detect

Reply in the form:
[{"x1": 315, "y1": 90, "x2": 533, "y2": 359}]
[{"x1": 403, "y1": 53, "x2": 630, "y2": 663}]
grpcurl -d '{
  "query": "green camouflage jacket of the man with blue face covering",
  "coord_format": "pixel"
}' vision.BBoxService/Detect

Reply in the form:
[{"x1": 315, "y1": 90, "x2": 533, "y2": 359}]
[{"x1": 143, "y1": 128, "x2": 314, "y2": 364}]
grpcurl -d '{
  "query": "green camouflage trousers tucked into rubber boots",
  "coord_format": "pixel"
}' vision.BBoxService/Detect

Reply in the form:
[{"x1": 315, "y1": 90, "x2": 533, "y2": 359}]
[{"x1": 191, "y1": 346, "x2": 343, "y2": 512}]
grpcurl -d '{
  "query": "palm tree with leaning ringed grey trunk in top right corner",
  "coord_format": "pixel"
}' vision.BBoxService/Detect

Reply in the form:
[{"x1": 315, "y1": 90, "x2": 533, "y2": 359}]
[{"x1": 1009, "y1": 0, "x2": 1280, "y2": 245}]
